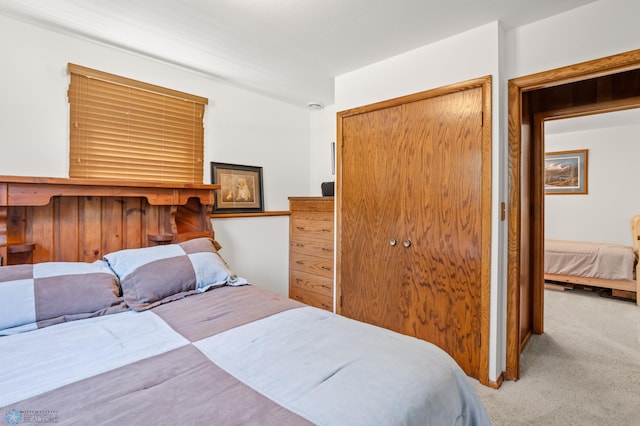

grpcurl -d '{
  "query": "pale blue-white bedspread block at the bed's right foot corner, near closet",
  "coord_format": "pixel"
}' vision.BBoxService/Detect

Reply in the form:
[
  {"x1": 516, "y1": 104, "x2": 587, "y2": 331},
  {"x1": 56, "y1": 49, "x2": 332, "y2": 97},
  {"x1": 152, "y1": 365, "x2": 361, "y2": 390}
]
[{"x1": 195, "y1": 308, "x2": 490, "y2": 426}]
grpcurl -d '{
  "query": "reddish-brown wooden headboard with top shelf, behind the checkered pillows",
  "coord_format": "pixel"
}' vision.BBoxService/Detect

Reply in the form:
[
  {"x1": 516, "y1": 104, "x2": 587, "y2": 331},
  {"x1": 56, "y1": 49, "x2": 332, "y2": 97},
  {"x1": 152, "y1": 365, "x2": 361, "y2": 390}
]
[{"x1": 0, "y1": 176, "x2": 219, "y2": 265}]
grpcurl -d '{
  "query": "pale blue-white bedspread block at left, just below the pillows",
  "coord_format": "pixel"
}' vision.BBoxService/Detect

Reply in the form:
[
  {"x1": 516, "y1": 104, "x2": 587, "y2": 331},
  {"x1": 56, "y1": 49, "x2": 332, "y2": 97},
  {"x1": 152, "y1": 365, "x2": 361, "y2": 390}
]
[{"x1": 0, "y1": 311, "x2": 189, "y2": 407}]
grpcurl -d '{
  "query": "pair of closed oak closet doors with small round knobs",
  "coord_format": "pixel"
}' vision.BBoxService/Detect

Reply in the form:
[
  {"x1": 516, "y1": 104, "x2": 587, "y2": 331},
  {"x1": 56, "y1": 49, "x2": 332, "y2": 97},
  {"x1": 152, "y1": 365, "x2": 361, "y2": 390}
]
[{"x1": 338, "y1": 83, "x2": 483, "y2": 377}]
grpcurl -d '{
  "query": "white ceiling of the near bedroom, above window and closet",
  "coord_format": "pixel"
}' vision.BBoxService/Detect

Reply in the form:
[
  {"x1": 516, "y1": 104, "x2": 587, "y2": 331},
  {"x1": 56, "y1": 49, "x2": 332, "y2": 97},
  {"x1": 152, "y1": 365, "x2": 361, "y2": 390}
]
[{"x1": 0, "y1": 0, "x2": 594, "y2": 106}]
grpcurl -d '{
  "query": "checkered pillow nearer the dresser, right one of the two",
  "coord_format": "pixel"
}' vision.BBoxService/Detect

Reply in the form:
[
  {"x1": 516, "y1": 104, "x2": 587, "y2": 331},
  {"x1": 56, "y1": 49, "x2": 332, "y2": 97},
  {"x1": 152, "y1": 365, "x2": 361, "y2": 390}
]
[{"x1": 104, "y1": 238, "x2": 247, "y2": 311}]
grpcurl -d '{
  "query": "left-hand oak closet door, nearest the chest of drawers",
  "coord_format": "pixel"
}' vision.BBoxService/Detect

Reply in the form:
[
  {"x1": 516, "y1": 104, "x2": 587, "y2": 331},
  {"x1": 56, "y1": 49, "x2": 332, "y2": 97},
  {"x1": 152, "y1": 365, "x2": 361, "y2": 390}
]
[{"x1": 340, "y1": 106, "x2": 406, "y2": 330}]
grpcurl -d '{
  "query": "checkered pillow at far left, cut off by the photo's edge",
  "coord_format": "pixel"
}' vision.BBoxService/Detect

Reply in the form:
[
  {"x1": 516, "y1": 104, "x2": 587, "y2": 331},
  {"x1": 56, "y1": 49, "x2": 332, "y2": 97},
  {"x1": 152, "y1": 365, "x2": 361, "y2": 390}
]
[{"x1": 0, "y1": 260, "x2": 127, "y2": 336}]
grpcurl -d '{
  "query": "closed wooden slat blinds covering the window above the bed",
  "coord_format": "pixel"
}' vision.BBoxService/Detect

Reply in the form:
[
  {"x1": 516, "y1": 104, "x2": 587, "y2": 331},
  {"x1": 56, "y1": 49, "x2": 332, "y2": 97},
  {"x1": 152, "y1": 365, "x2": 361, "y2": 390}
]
[{"x1": 68, "y1": 64, "x2": 208, "y2": 183}]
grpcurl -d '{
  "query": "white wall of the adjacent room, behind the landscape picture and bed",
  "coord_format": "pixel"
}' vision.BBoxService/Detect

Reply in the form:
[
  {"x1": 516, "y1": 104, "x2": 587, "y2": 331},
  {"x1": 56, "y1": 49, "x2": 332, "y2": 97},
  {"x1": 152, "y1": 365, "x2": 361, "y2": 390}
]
[{"x1": 544, "y1": 123, "x2": 640, "y2": 246}]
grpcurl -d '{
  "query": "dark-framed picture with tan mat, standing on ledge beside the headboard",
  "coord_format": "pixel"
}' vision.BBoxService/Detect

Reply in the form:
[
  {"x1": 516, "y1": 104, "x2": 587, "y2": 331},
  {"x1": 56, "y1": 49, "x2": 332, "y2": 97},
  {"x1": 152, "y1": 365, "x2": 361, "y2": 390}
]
[{"x1": 211, "y1": 162, "x2": 264, "y2": 214}]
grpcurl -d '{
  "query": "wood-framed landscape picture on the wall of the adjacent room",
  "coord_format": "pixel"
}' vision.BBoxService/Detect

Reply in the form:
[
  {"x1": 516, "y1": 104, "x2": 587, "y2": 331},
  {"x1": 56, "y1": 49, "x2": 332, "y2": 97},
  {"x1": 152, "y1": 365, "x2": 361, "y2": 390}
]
[{"x1": 544, "y1": 149, "x2": 589, "y2": 194}]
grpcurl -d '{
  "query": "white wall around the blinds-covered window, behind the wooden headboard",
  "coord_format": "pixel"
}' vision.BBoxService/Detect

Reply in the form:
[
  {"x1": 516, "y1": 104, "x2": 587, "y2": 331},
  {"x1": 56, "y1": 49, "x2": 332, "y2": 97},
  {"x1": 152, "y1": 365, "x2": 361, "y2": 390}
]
[{"x1": 0, "y1": 16, "x2": 311, "y2": 294}]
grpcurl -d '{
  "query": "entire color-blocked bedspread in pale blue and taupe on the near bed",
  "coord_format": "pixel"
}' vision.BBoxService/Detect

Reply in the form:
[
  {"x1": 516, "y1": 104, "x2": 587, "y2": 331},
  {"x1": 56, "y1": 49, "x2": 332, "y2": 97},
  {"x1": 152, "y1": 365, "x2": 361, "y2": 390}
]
[{"x1": 0, "y1": 286, "x2": 490, "y2": 426}]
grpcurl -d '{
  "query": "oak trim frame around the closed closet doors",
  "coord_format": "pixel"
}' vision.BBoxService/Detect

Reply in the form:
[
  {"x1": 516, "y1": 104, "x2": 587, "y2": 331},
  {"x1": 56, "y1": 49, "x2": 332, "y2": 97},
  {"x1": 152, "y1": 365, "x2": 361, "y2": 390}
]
[{"x1": 335, "y1": 75, "x2": 492, "y2": 388}]
